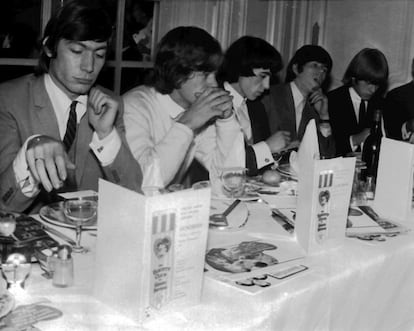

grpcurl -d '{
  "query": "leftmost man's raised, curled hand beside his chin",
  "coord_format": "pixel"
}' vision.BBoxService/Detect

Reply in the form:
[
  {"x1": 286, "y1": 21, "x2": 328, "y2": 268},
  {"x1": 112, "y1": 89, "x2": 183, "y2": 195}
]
[{"x1": 88, "y1": 87, "x2": 118, "y2": 139}]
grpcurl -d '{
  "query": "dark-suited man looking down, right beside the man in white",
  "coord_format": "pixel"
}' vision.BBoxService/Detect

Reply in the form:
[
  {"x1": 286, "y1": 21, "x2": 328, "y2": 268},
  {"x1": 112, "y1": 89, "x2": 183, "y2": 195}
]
[{"x1": 217, "y1": 36, "x2": 290, "y2": 175}]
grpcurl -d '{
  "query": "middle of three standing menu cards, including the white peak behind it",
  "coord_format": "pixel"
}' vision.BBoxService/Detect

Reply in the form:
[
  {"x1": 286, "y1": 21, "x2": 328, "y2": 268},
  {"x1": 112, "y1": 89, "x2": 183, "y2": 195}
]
[{"x1": 295, "y1": 122, "x2": 356, "y2": 254}]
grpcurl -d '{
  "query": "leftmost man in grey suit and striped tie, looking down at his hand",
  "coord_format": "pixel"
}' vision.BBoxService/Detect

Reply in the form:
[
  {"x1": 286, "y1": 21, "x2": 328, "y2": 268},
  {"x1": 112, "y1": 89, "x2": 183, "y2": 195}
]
[{"x1": 0, "y1": 0, "x2": 142, "y2": 212}]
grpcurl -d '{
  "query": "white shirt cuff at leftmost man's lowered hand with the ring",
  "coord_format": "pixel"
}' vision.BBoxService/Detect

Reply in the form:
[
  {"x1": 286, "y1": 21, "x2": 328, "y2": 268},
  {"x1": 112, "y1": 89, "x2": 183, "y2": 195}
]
[{"x1": 13, "y1": 135, "x2": 40, "y2": 198}]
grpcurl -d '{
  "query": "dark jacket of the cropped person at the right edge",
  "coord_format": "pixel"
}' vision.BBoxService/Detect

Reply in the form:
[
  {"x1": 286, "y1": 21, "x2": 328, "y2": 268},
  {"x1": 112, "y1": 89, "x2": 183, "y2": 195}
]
[{"x1": 383, "y1": 81, "x2": 414, "y2": 140}]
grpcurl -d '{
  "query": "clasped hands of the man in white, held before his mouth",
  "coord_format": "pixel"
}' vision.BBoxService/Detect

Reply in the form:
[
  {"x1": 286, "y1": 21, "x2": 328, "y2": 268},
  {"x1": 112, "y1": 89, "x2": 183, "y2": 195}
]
[{"x1": 177, "y1": 87, "x2": 233, "y2": 131}]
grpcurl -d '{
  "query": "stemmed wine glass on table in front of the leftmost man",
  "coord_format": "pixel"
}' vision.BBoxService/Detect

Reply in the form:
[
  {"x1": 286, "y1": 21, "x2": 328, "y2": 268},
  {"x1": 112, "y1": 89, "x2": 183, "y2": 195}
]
[{"x1": 63, "y1": 198, "x2": 97, "y2": 253}]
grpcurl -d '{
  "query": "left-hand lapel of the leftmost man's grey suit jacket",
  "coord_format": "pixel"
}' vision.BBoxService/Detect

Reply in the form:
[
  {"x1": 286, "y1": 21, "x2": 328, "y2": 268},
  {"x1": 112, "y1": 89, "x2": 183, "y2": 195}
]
[{"x1": 32, "y1": 76, "x2": 61, "y2": 140}]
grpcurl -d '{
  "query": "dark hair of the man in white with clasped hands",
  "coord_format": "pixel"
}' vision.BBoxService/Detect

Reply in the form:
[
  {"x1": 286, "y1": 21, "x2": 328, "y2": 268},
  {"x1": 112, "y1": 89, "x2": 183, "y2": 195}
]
[{"x1": 153, "y1": 26, "x2": 222, "y2": 94}]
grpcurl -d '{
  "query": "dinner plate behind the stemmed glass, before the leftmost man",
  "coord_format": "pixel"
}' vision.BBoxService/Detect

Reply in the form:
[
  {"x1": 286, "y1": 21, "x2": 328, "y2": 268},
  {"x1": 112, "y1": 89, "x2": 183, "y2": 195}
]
[{"x1": 39, "y1": 201, "x2": 97, "y2": 230}]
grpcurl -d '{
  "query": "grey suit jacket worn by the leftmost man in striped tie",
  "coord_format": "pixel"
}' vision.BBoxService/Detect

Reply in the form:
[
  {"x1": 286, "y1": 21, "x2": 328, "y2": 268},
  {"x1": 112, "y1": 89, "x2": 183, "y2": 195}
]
[{"x1": 0, "y1": 75, "x2": 142, "y2": 211}]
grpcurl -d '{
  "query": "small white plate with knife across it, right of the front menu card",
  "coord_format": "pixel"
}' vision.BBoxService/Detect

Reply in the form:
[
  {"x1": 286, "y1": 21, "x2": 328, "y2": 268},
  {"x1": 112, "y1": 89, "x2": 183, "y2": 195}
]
[{"x1": 210, "y1": 200, "x2": 249, "y2": 231}]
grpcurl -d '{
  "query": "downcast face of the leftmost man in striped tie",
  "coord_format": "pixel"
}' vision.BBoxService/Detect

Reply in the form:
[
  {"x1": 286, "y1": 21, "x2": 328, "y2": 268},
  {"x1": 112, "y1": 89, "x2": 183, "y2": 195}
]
[{"x1": 48, "y1": 39, "x2": 107, "y2": 99}]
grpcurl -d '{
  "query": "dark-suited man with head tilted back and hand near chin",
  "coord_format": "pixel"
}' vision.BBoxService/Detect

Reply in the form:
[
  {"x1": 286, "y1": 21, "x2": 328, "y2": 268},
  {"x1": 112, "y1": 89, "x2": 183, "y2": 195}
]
[{"x1": 263, "y1": 45, "x2": 335, "y2": 158}]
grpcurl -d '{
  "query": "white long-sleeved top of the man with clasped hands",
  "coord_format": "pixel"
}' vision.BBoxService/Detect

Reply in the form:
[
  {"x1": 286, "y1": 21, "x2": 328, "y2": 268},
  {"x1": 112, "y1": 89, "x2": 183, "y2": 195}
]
[{"x1": 123, "y1": 86, "x2": 245, "y2": 190}]
